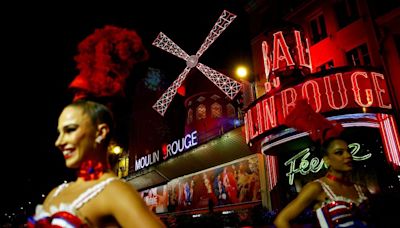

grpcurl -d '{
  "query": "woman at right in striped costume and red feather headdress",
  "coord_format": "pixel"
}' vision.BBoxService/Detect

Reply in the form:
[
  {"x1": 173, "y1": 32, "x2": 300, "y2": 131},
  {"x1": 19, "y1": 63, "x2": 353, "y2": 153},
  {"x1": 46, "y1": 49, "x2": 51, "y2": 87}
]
[{"x1": 274, "y1": 100, "x2": 368, "y2": 228}]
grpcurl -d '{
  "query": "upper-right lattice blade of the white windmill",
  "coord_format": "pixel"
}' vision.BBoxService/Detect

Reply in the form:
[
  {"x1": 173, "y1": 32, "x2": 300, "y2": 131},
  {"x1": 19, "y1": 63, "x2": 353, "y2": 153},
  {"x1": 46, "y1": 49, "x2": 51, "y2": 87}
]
[{"x1": 196, "y1": 10, "x2": 236, "y2": 58}]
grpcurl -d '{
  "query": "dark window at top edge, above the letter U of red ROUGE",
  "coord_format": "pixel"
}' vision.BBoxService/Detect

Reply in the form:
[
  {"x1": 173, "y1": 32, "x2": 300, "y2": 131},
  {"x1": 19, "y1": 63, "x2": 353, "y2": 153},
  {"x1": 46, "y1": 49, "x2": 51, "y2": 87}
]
[{"x1": 335, "y1": 0, "x2": 360, "y2": 28}]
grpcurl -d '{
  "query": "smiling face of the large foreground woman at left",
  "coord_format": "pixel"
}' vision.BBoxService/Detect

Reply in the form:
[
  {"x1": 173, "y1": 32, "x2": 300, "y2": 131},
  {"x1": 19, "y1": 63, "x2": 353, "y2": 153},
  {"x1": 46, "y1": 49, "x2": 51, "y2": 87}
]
[{"x1": 55, "y1": 106, "x2": 96, "y2": 168}]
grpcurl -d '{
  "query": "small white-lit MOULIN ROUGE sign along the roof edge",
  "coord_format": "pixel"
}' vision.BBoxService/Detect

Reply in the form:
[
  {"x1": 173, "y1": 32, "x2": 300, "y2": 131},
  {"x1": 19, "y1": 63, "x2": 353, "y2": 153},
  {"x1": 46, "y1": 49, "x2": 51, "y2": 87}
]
[{"x1": 135, "y1": 131, "x2": 198, "y2": 171}]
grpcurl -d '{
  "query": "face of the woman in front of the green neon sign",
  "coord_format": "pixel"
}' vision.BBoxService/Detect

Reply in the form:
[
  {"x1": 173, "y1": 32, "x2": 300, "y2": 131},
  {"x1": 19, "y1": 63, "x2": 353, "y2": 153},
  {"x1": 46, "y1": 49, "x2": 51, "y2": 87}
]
[{"x1": 324, "y1": 139, "x2": 353, "y2": 171}]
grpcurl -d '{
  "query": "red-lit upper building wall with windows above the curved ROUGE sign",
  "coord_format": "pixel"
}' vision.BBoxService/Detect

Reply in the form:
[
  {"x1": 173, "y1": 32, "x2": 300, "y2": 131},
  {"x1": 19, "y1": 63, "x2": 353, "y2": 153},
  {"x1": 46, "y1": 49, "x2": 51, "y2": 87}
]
[{"x1": 248, "y1": 0, "x2": 400, "y2": 117}]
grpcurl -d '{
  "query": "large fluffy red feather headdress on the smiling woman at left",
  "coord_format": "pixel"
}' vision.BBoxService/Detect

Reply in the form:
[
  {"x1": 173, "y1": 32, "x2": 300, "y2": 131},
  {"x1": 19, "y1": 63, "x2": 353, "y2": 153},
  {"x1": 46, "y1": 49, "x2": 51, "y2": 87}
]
[{"x1": 69, "y1": 25, "x2": 148, "y2": 100}]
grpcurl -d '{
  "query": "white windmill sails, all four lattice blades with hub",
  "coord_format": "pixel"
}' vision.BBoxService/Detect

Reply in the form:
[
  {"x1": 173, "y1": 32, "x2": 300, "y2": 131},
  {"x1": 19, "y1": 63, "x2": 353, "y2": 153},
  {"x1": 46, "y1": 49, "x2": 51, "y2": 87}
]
[{"x1": 153, "y1": 10, "x2": 241, "y2": 116}]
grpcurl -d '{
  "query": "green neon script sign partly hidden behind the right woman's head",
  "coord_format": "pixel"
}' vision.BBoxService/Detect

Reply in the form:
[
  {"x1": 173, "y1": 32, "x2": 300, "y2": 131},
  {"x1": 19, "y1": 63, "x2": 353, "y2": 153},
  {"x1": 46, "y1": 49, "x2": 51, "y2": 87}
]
[{"x1": 284, "y1": 143, "x2": 372, "y2": 185}]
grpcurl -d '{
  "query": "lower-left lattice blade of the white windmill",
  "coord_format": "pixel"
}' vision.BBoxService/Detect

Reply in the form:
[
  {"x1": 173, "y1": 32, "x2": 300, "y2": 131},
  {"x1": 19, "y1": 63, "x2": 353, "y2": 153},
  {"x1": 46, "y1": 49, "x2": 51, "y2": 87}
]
[{"x1": 153, "y1": 67, "x2": 191, "y2": 116}]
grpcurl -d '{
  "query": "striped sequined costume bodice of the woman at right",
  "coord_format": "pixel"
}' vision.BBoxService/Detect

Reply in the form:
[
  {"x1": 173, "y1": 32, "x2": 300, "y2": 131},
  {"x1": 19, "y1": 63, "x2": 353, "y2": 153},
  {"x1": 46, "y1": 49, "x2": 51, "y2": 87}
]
[{"x1": 315, "y1": 179, "x2": 368, "y2": 228}]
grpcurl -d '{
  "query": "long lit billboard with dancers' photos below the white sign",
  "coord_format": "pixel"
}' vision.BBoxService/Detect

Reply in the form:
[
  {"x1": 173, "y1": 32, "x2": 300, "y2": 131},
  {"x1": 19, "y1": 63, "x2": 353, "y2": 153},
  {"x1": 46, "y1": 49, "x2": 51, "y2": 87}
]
[{"x1": 141, "y1": 155, "x2": 261, "y2": 213}]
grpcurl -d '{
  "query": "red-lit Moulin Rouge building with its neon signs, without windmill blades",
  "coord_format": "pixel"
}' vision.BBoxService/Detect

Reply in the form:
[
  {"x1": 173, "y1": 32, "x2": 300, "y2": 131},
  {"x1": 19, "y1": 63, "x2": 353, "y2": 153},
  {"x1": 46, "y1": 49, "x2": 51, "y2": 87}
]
[{"x1": 123, "y1": 1, "x2": 400, "y2": 222}]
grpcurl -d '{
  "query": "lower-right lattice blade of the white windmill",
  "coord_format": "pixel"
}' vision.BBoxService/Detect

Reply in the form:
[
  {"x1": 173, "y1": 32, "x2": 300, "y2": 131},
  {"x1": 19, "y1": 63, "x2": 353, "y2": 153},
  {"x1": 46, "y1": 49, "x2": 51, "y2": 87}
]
[{"x1": 196, "y1": 63, "x2": 242, "y2": 99}]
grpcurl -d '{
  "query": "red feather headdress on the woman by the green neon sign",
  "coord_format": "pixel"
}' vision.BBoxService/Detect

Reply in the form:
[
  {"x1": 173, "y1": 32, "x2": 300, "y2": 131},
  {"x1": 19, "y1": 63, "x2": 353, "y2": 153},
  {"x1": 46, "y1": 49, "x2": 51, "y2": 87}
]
[{"x1": 285, "y1": 99, "x2": 344, "y2": 144}]
